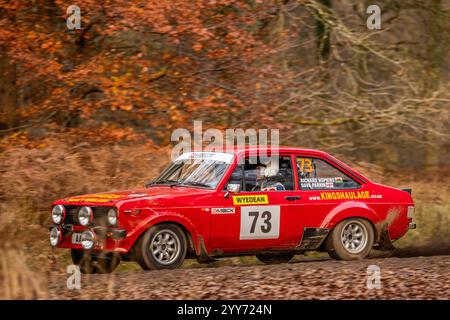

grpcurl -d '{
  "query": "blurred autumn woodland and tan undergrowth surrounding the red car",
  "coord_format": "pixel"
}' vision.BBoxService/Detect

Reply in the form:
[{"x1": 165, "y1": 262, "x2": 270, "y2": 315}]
[{"x1": 0, "y1": 0, "x2": 450, "y2": 298}]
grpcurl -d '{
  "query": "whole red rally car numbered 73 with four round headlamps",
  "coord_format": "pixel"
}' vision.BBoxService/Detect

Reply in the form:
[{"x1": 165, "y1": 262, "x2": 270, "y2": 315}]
[{"x1": 50, "y1": 147, "x2": 415, "y2": 273}]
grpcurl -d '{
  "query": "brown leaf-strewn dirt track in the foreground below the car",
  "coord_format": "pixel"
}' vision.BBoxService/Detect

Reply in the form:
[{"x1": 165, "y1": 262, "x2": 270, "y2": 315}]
[{"x1": 49, "y1": 254, "x2": 450, "y2": 299}]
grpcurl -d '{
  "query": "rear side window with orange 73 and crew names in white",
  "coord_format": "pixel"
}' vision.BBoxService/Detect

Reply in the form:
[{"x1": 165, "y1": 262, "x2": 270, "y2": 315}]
[{"x1": 295, "y1": 157, "x2": 360, "y2": 190}]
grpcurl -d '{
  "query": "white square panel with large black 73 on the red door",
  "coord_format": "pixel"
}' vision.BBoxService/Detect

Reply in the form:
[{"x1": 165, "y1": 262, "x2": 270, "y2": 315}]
[{"x1": 239, "y1": 206, "x2": 280, "y2": 240}]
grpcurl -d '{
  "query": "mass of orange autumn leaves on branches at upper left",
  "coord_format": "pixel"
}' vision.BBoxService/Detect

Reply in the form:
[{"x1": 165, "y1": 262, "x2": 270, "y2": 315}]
[{"x1": 0, "y1": 1, "x2": 280, "y2": 143}]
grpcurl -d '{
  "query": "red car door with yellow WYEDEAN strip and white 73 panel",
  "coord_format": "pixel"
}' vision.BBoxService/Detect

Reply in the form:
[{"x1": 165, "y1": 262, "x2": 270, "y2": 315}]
[{"x1": 211, "y1": 155, "x2": 303, "y2": 253}]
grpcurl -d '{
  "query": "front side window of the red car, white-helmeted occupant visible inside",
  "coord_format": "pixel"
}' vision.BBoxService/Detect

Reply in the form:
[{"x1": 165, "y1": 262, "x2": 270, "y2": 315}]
[{"x1": 227, "y1": 156, "x2": 294, "y2": 192}]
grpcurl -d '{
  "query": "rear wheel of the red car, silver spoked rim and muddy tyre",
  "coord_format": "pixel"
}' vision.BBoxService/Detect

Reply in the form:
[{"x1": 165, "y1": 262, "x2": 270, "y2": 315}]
[{"x1": 326, "y1": 218, "x2": 374, "y2": 260}]
